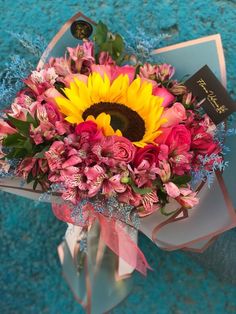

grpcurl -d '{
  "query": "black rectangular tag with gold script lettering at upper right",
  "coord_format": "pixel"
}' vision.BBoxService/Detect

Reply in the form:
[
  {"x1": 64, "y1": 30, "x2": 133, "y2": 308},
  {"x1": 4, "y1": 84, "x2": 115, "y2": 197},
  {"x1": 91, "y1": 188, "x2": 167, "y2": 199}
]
[{"x1": 185, "y1": 65, "x2": 236, "y2": 124}]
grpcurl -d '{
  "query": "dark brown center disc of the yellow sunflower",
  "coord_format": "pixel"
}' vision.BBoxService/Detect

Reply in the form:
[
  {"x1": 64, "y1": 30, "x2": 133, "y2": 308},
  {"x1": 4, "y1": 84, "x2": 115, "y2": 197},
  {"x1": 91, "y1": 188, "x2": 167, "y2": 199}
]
[{"x1": 82, "y1": 102, "x2": 145, "y2": 142}]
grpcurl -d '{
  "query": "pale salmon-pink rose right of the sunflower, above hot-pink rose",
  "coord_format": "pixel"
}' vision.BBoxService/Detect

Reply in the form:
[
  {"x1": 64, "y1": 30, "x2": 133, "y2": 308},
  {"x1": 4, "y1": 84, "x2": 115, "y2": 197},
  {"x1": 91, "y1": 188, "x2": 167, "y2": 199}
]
[{"x1": 162, "y1": 102, "x2": 187, "y2": 127}]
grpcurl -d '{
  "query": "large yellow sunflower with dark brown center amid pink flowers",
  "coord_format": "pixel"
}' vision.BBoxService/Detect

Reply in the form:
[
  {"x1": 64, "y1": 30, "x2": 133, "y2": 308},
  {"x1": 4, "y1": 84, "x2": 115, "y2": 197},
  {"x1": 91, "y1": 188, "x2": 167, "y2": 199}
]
[{"x1": 56, "y1": 72, "x2": 166, "y2": 147}]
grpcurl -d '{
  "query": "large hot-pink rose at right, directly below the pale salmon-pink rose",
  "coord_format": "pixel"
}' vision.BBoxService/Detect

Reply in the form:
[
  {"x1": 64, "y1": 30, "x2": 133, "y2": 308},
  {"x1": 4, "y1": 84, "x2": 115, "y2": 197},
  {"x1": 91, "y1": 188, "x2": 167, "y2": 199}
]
[{"x1": 155, "y1": 124, "x2": 191, "y2": 154}]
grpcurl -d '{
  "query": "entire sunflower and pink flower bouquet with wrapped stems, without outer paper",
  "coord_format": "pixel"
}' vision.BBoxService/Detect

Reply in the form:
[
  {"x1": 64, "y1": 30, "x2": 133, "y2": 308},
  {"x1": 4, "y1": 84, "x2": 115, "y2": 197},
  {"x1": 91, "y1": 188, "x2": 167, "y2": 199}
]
[{"x1": 0, "y1": 11, "x2": 235, "y2": 313}]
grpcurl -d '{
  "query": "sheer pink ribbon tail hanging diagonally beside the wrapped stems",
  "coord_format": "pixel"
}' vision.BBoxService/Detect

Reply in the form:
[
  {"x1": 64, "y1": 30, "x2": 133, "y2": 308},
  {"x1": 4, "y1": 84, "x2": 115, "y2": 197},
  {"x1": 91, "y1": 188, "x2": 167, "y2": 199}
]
[{"x1": 98, "y1": 214, "x2": 152, "y2": 276}]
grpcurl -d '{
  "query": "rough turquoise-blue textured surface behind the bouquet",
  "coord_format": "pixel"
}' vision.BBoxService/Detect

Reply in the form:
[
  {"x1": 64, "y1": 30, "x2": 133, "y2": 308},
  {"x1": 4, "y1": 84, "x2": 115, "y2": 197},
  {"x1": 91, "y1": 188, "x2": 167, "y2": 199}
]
[{"x1": 0, "y1": 0, "x2": 236, "y2": 314}]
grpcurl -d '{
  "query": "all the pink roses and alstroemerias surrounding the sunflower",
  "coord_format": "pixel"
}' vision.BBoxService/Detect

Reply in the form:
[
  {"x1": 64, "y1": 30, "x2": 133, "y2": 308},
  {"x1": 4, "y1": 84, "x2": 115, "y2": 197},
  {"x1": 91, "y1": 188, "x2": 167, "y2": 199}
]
[{"x1": 0, "y1": 41, "x2": 221, "y2": 216}]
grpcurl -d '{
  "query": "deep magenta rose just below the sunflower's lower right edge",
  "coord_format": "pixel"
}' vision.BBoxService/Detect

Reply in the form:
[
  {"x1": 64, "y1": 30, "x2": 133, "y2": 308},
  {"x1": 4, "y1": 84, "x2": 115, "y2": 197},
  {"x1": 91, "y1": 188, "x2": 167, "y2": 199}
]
[{"x1": 133, "y1": 144, "x2": 160, "y2": 168}]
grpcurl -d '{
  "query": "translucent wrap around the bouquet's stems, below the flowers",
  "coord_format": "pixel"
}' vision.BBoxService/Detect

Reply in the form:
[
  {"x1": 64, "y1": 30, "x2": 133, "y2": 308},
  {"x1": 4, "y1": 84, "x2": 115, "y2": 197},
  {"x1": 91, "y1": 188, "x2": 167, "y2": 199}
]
[{"x1": 58, "y1": 223, "x2": 132, "y2": 314}]
